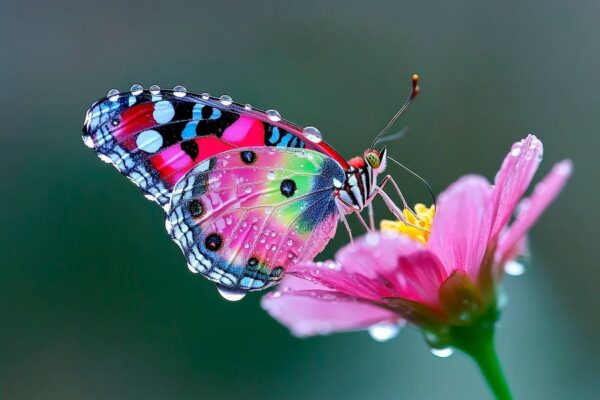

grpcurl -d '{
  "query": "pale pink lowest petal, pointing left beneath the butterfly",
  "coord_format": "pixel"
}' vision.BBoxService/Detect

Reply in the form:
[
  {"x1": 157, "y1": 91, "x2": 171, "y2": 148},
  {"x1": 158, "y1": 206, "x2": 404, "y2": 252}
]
[{"x1": 261, "y1": 276, "x2": 400, "y2": 337}]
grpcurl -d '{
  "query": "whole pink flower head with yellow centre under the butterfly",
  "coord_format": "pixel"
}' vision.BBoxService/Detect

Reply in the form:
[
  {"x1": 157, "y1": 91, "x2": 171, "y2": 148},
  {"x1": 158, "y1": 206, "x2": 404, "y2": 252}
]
[{"x1": 262, "y1": 135, "x2": 572, "y2": 338}]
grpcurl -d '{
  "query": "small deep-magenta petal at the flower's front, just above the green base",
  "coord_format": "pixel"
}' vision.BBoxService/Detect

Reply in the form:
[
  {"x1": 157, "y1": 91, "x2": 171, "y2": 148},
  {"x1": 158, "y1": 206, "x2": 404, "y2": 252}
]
[{"x1": 398, "y1": 251, "x2": 448, "y2": 309}]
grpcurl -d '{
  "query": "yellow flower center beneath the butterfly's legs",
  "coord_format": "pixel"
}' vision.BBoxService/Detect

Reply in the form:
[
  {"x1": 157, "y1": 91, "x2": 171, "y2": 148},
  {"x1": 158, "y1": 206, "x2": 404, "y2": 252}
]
[{"x1": 380, "y1": 204, "x2": 435, "y2": 244}]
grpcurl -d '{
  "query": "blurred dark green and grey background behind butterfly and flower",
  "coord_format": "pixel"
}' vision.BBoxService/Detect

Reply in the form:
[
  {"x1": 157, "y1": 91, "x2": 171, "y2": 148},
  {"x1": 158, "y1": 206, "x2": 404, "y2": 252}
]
[{"x1": 0, "y1": 0, "x2": 600, "y2": 399}]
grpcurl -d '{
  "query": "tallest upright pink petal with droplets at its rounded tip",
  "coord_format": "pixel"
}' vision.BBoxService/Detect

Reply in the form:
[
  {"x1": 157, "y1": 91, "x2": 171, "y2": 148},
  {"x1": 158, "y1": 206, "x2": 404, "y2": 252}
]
[{"x1": 490, "y1": 135, "x2": 544, "y2": 238}]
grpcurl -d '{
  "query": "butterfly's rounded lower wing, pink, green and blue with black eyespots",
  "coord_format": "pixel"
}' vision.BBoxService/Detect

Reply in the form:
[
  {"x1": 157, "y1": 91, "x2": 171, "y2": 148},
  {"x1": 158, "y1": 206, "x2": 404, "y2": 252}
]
[{"x1": 166, "y1": 147, "x2": 344, "y2": 291}]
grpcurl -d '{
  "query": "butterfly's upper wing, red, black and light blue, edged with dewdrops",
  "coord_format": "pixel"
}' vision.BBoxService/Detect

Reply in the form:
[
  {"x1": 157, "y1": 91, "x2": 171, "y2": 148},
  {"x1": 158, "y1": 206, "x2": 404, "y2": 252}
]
[{"x1": 83, "y1": 88, "x2": 346, "y2": 207}]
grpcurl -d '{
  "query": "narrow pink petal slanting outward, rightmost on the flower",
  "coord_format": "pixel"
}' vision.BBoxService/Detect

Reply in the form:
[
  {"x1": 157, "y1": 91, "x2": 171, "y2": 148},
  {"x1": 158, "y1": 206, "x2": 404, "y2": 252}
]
[{"x1": 496, "y1": 160, "x2": 573, "y2": 265}]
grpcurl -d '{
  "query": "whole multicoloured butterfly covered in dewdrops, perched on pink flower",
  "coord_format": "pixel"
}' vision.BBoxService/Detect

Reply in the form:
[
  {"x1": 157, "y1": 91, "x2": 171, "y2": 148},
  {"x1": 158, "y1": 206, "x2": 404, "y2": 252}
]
[{"x1": 83, "y1": 78, "x2": 418, "y2": 300}]
